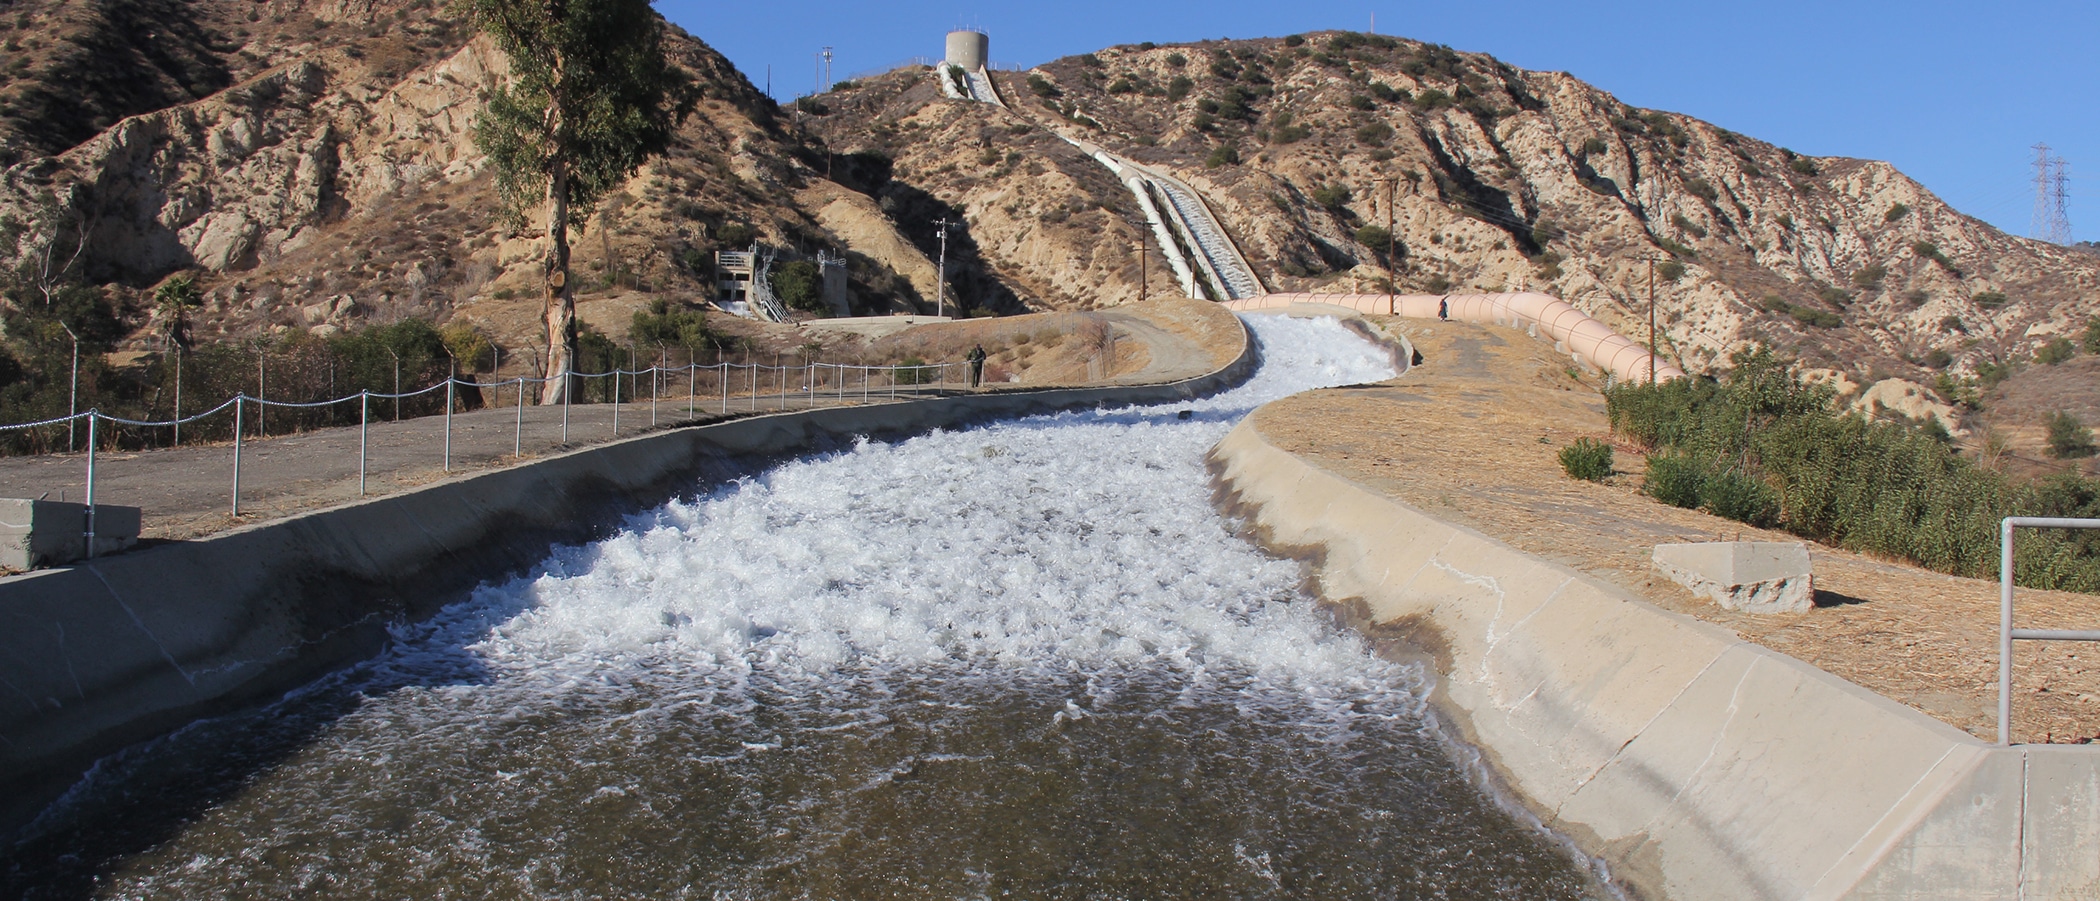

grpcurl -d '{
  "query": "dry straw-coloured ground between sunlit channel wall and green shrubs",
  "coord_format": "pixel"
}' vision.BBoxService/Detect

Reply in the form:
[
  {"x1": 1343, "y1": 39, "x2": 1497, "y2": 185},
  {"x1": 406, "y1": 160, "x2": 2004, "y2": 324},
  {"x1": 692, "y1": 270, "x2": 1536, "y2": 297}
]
[{"x1": 1256, "y1": 319, "x2": 2100, "y2": 741}]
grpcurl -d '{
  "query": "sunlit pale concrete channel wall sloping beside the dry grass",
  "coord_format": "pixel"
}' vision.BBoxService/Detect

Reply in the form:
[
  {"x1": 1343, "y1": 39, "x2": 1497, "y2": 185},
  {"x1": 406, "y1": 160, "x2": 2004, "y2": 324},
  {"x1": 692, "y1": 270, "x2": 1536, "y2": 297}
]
[{"x1": 1212, "y1": 416, "x2": 2100, "y2": 901}]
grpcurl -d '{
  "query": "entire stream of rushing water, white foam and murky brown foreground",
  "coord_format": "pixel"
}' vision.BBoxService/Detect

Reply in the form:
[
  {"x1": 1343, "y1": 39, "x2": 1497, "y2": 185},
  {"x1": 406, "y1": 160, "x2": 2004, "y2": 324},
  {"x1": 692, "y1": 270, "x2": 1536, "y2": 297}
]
[{"x1": 6, "y1": 317, "x2": 1594, "y2": 899}]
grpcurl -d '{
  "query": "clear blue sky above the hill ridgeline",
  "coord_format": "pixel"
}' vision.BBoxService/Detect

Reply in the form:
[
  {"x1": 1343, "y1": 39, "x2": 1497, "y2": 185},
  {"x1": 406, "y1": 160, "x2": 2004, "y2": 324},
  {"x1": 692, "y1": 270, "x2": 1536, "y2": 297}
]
[{"x1": 657, "y1": 0, "x2": 2100, "y2": 242}]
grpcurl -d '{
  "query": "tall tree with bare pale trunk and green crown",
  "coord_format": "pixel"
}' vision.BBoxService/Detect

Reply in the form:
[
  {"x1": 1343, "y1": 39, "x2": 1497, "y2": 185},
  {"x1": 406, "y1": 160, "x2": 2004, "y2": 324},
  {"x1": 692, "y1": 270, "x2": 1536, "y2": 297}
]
[{"x1": 456, "y1": 0, "x2": 697, "y2": 403}]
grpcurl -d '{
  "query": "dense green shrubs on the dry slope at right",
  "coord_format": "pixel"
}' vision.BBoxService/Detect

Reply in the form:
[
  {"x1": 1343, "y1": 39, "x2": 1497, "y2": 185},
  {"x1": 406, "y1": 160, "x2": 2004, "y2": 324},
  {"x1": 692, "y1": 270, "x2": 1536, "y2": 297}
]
[{"x1": 1607, "y1": 347, "x2": 2100, "y2": 592}]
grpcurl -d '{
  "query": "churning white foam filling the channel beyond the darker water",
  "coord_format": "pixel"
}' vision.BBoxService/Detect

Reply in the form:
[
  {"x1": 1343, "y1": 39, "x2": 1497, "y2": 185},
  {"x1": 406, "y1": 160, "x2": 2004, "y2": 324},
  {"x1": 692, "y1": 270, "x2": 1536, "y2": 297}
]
[{"x1": 397, "y1": 317, "x2": 1392, "y2": 693}]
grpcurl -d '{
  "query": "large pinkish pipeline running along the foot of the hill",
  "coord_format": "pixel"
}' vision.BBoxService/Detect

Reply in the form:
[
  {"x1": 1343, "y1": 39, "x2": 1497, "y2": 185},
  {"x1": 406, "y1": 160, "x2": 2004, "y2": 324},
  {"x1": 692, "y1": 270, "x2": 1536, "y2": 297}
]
[{"x1": 1226, "y1": 292, "x2": 1684, "y2": 382}]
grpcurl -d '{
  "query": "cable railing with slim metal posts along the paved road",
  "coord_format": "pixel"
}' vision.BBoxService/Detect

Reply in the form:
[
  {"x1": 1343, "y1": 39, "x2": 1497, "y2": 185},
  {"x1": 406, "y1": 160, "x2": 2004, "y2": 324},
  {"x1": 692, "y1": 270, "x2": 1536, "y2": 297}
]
[{"x1": 18, "y1": 361, "x2": 965, "y2": 557}]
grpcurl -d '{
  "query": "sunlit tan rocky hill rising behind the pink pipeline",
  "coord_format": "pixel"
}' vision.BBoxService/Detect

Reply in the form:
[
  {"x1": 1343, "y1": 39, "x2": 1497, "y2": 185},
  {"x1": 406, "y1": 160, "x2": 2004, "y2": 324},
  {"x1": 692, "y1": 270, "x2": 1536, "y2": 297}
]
[{"x1": 817, "y1": 34, "x2": 2100, "y2": 382}]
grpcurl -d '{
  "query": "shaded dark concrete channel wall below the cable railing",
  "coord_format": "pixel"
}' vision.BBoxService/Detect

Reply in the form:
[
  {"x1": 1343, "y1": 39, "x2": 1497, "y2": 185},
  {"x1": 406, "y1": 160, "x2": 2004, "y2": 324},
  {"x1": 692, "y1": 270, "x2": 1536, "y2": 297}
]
[{"x1": 0, "y1": 330, "x2": 1256, "y2": 838}]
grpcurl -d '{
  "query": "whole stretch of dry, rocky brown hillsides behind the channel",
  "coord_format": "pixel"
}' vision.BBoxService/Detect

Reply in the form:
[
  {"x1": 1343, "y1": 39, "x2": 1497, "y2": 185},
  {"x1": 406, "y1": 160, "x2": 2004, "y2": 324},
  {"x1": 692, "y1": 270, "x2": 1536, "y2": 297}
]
[{"x1": 0, "y1": 15, "x2": 2100, "y2": 432}]
